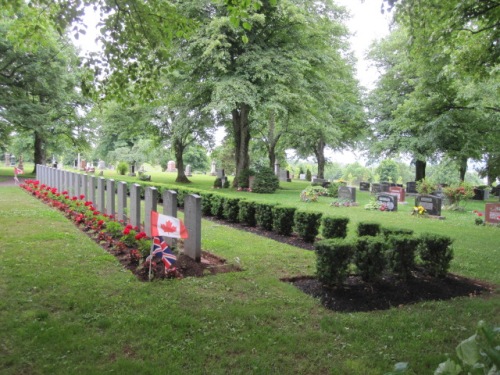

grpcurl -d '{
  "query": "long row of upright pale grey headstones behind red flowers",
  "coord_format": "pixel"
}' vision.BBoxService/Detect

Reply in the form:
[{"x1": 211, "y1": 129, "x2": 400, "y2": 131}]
[{"x1": 36, "y1": 164, "x2": 201, "y2": 261}]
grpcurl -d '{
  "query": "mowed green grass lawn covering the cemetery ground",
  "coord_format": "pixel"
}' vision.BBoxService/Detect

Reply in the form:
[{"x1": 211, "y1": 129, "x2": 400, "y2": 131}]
[{"x1": 0, "y1": 169, "x2": 500, "y2": 374}]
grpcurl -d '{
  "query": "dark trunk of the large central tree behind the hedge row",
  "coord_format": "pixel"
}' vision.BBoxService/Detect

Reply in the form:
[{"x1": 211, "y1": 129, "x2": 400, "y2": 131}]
[{"x1": 231, "y1": 104, "x2": 250, "y2": 187}]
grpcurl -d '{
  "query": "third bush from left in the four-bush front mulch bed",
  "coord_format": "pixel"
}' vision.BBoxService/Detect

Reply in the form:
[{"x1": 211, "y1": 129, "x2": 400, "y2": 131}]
[{"x1": 387, "y1": 234, "x2": 419, "y2": 280}]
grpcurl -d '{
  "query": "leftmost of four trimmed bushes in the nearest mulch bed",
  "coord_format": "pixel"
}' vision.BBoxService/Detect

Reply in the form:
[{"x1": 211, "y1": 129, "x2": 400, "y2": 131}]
[{"x1": 314, "y1": 239, "x2": 354, "y2": 287}]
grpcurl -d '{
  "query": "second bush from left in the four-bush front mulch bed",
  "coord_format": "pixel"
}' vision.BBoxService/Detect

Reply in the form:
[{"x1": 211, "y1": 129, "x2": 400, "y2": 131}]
[{"x1": 353, "y1": 236, "x2": 387, "y2": 282}]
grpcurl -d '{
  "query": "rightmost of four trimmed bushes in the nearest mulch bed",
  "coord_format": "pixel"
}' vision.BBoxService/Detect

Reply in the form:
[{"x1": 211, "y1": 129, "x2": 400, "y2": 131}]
[{"x1": 418, "y1": 233, "x2": 453, "y2": 277}]
